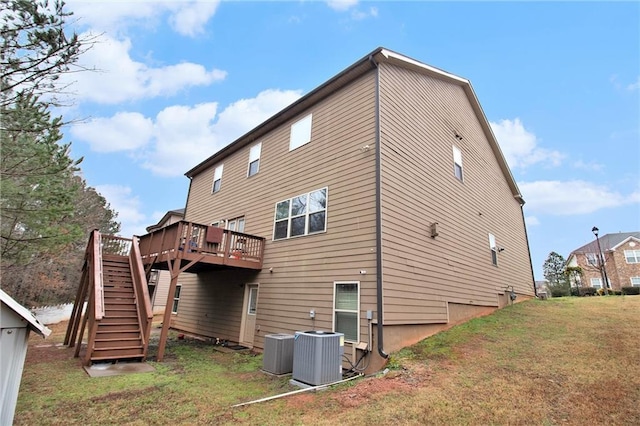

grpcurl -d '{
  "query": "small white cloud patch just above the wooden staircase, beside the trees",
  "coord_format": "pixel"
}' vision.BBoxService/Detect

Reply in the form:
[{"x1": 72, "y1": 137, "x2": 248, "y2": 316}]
[{"x1": 96, "y1": 185, "x2": 148, "y2": 237}]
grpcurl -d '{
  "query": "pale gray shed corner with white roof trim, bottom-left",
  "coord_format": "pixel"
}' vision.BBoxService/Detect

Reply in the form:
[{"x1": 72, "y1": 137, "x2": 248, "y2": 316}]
[{"x1": 0, "y1": 289, "x2": 51, "y2": 425}]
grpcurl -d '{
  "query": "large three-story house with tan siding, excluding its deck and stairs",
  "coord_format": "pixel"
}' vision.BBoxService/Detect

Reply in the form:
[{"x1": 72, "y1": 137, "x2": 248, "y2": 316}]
[{"x1": 159, "y1": 48, "x2": 535, "y2": 370}]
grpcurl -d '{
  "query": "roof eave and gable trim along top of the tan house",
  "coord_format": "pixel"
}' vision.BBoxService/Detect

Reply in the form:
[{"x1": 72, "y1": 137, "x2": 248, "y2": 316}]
[{"x1": 185, "y1": 47, "x2": 524, "y2": 204}]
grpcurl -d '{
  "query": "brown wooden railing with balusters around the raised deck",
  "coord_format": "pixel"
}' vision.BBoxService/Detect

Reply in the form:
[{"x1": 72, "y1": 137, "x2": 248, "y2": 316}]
[{"x1": 139, "y1": 221, "x2": 265, "y2": 267}]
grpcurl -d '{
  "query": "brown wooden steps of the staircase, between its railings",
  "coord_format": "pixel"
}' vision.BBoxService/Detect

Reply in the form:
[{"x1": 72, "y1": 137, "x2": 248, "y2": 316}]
[{"x1": 90, "y1": 255, "x2": 145, "y2": 362}]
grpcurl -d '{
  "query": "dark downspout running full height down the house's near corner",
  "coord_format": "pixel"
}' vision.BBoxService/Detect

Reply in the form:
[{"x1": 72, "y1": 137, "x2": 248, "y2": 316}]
[{"x1": 369, "y1": 55, "x2": 389, "y2": 359}]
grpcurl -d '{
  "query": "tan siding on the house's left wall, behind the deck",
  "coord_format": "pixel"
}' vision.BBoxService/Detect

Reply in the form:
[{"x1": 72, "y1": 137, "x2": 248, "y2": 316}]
[{"x1": 179, "y1": 73, "x2": 376, "y2": 348}]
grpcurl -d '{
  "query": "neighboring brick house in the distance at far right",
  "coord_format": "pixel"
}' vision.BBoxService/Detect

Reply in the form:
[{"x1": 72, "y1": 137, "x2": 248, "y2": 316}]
[{"x1": 567, "y1": 232, "x2": 640, "y2": 290}]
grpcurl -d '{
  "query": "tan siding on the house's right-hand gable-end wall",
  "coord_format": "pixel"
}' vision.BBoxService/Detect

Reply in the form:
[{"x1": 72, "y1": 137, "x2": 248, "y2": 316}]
[{"x1": 380, "y1": 64, "x2": 533, "y2": 324}]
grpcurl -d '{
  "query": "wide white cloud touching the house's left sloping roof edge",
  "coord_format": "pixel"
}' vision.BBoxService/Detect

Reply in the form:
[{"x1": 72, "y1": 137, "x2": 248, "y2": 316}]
[{"x1": 72, "y1": 90, "x2": 301, "y2": 176}]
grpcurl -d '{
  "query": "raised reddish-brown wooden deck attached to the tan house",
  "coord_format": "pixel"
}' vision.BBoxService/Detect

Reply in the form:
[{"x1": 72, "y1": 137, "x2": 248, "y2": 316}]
[{"x1": 139, "y1": 221, "x2": 265, "y2": 273}]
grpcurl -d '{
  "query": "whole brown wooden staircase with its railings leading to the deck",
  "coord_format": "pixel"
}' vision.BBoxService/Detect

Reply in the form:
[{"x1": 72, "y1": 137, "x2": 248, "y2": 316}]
[{"x1": 64, "y1": 231, "x2": 153, "y2": 365}]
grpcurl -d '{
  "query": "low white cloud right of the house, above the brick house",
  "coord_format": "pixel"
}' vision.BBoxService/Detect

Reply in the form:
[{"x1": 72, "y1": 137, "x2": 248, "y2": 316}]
[{"x1": 519, "y1": 180, "x2": 640, "y2": 216}]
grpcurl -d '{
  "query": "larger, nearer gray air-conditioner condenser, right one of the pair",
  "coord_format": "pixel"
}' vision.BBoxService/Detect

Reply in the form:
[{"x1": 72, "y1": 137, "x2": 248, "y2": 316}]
[{"x1": 291, "y1": 331, "x2": 344, "y2": 386}]
